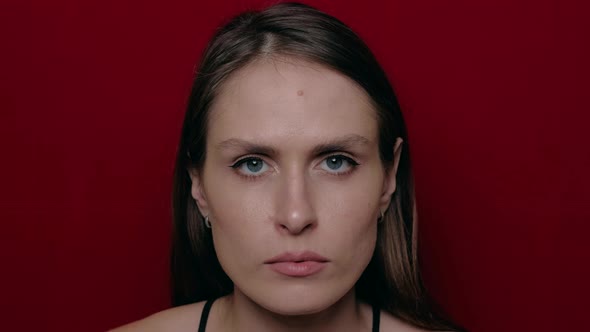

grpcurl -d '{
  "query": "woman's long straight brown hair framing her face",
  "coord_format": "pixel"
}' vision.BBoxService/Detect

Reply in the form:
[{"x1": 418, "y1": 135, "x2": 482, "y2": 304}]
[{"x1": 171, "y1": 3, "x2": 458, "y2": 330}]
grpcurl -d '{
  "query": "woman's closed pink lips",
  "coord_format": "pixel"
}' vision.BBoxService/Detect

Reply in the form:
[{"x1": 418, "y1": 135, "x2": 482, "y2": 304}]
[{"x1": 264, "y1": 251, "x2": 329, "y2": 277}]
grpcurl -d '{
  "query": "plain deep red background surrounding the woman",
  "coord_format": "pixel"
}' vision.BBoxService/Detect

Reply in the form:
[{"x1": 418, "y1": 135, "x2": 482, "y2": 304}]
[{"x1": 0, "y1": 0, "x2": 590, "y2": 332}]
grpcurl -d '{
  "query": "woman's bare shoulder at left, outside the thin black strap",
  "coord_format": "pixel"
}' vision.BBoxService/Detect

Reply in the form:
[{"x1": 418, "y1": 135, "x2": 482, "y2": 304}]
[{"x1": 110, "y1": 301, "x2": 205, "y2": 332}]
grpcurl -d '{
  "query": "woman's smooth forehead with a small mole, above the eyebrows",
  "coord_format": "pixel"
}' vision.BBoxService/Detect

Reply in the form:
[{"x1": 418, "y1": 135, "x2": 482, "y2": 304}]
[{"x1": 208, "y1": 59, "x2": 377, "y2": 145}]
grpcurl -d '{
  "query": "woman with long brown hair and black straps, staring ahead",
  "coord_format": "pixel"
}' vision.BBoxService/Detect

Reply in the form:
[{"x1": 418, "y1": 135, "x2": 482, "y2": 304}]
[{"x1": 113, "y1": 4, "x2": 458, "y2": 332}]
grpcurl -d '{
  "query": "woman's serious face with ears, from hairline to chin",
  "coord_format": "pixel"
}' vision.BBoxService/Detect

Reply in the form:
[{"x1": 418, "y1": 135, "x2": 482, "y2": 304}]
[{"x1": 191, "y1": 60, "x2": 399, "y2": 315}]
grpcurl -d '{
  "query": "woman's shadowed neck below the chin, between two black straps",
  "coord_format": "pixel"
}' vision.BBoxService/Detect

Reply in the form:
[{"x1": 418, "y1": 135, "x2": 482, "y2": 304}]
[{"x1": 218, "y1": 289, "x2": 372, "y2": 332}]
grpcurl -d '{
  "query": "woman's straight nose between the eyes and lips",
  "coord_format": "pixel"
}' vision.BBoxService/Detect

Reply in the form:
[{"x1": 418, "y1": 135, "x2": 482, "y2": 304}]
[{"x1": 275, "y1": 170, "x2": 317, "y2": 235}]
